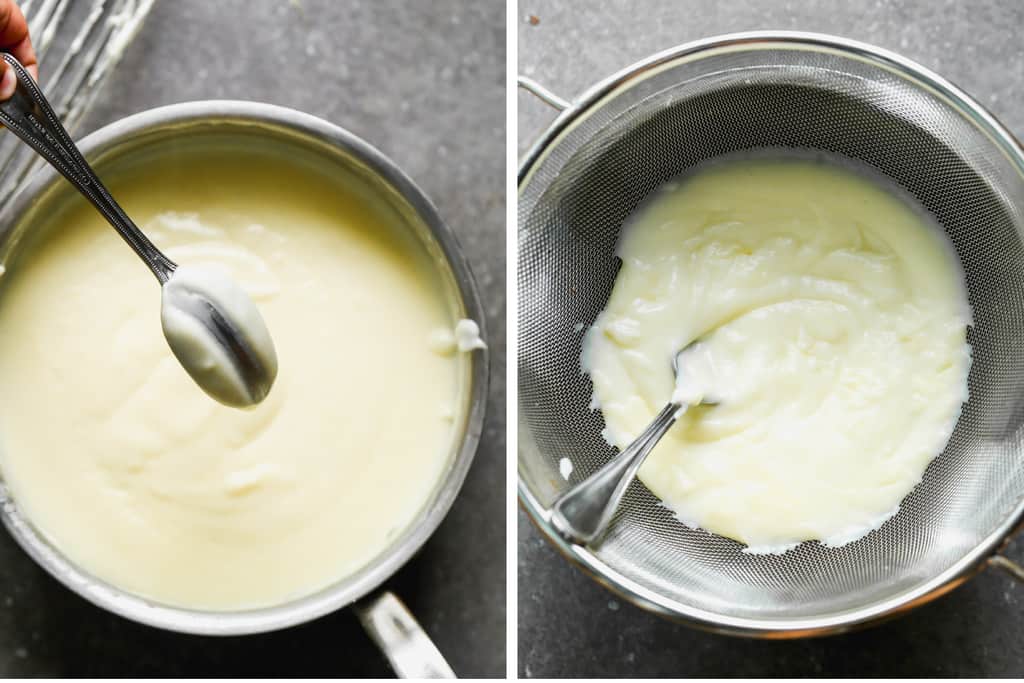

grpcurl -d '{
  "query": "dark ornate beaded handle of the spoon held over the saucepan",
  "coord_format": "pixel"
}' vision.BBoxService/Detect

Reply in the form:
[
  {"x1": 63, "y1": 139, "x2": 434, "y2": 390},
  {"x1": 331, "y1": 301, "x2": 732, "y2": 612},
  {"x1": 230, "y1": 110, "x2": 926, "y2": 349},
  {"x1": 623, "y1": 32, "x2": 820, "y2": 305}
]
[{"x1": 0, "y1": 53, "x2": 177, "y2": 285}]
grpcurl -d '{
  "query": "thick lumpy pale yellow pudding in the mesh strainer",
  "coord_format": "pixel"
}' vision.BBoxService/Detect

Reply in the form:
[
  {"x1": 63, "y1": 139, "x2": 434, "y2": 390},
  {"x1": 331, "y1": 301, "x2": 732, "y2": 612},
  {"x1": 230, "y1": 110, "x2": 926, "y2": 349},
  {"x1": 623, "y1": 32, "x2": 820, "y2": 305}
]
[{"x1": 582, "y1": 157, "x2": 971, "y2": 552}]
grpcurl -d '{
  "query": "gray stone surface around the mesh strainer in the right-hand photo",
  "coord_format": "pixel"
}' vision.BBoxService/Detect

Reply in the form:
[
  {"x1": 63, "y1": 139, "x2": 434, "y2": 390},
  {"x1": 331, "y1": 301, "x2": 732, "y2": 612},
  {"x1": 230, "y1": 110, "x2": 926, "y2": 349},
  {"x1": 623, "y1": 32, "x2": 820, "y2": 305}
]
[{"x1": 517, "y1": 0, "x2": 1024, "y2": 677}]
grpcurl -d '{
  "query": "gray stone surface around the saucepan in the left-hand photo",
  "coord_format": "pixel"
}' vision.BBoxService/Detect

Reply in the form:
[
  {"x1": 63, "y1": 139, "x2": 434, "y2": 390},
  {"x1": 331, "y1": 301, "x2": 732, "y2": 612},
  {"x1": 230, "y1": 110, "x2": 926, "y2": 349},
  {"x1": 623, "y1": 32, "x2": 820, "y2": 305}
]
[{"x1": 0, "y1": 0, "x2": 506, "y2": 677}]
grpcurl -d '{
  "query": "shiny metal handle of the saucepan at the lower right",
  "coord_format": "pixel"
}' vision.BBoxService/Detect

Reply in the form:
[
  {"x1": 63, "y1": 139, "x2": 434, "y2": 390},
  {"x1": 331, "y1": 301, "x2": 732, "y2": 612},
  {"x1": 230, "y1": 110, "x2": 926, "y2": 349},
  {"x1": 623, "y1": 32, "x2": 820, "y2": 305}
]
[{"x1": 355, "y1": 591, "x2": 456, "y2": 678}]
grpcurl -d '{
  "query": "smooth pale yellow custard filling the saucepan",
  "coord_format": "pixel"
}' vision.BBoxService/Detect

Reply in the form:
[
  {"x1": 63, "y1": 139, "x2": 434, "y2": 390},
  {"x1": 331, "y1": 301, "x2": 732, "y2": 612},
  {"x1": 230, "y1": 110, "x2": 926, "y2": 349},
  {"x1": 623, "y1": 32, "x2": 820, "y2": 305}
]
[{"x1": 0, "y1": 145, "x2": 470, "y2": 611}]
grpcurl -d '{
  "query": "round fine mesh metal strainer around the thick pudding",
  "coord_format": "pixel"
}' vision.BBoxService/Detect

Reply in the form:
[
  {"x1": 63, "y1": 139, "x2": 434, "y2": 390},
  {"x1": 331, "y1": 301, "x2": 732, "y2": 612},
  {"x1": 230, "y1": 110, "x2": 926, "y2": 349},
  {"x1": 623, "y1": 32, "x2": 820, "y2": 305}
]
[{"x1": 517, "y1": 33, "x2": 1024, "y2": 637}]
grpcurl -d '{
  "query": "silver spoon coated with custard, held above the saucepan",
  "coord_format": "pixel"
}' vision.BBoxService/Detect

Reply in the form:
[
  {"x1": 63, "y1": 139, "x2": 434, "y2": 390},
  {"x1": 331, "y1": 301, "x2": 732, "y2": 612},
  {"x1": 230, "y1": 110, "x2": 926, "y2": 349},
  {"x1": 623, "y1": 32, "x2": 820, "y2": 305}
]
[{"x1": 0, "y1": 53, "x2": 278, "y2": 408}]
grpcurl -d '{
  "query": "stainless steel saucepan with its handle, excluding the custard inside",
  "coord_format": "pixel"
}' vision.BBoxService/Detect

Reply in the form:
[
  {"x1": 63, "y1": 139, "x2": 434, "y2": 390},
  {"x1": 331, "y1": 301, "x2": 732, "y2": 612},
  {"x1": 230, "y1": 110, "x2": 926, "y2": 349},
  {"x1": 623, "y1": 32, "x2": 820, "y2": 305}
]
[{"x1": 0, "y1": 101, "x2": 488, "y2": 677}]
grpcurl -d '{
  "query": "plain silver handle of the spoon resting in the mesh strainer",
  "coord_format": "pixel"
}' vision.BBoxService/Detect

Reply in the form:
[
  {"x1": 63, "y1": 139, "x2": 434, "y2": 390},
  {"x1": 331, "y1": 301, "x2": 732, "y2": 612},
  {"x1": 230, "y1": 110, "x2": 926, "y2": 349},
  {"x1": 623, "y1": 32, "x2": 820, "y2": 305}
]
[{"x1": 551, "y1": 403, "x2": 686, "y2": 546}]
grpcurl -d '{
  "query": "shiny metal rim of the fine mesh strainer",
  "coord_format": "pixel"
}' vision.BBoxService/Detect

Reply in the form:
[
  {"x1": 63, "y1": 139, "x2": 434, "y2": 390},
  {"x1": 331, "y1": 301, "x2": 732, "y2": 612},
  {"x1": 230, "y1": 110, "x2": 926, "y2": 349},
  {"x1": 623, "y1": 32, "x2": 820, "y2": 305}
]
[{"x1": 517, "y1": 31, "x2": 1024, "y2": 638}]
